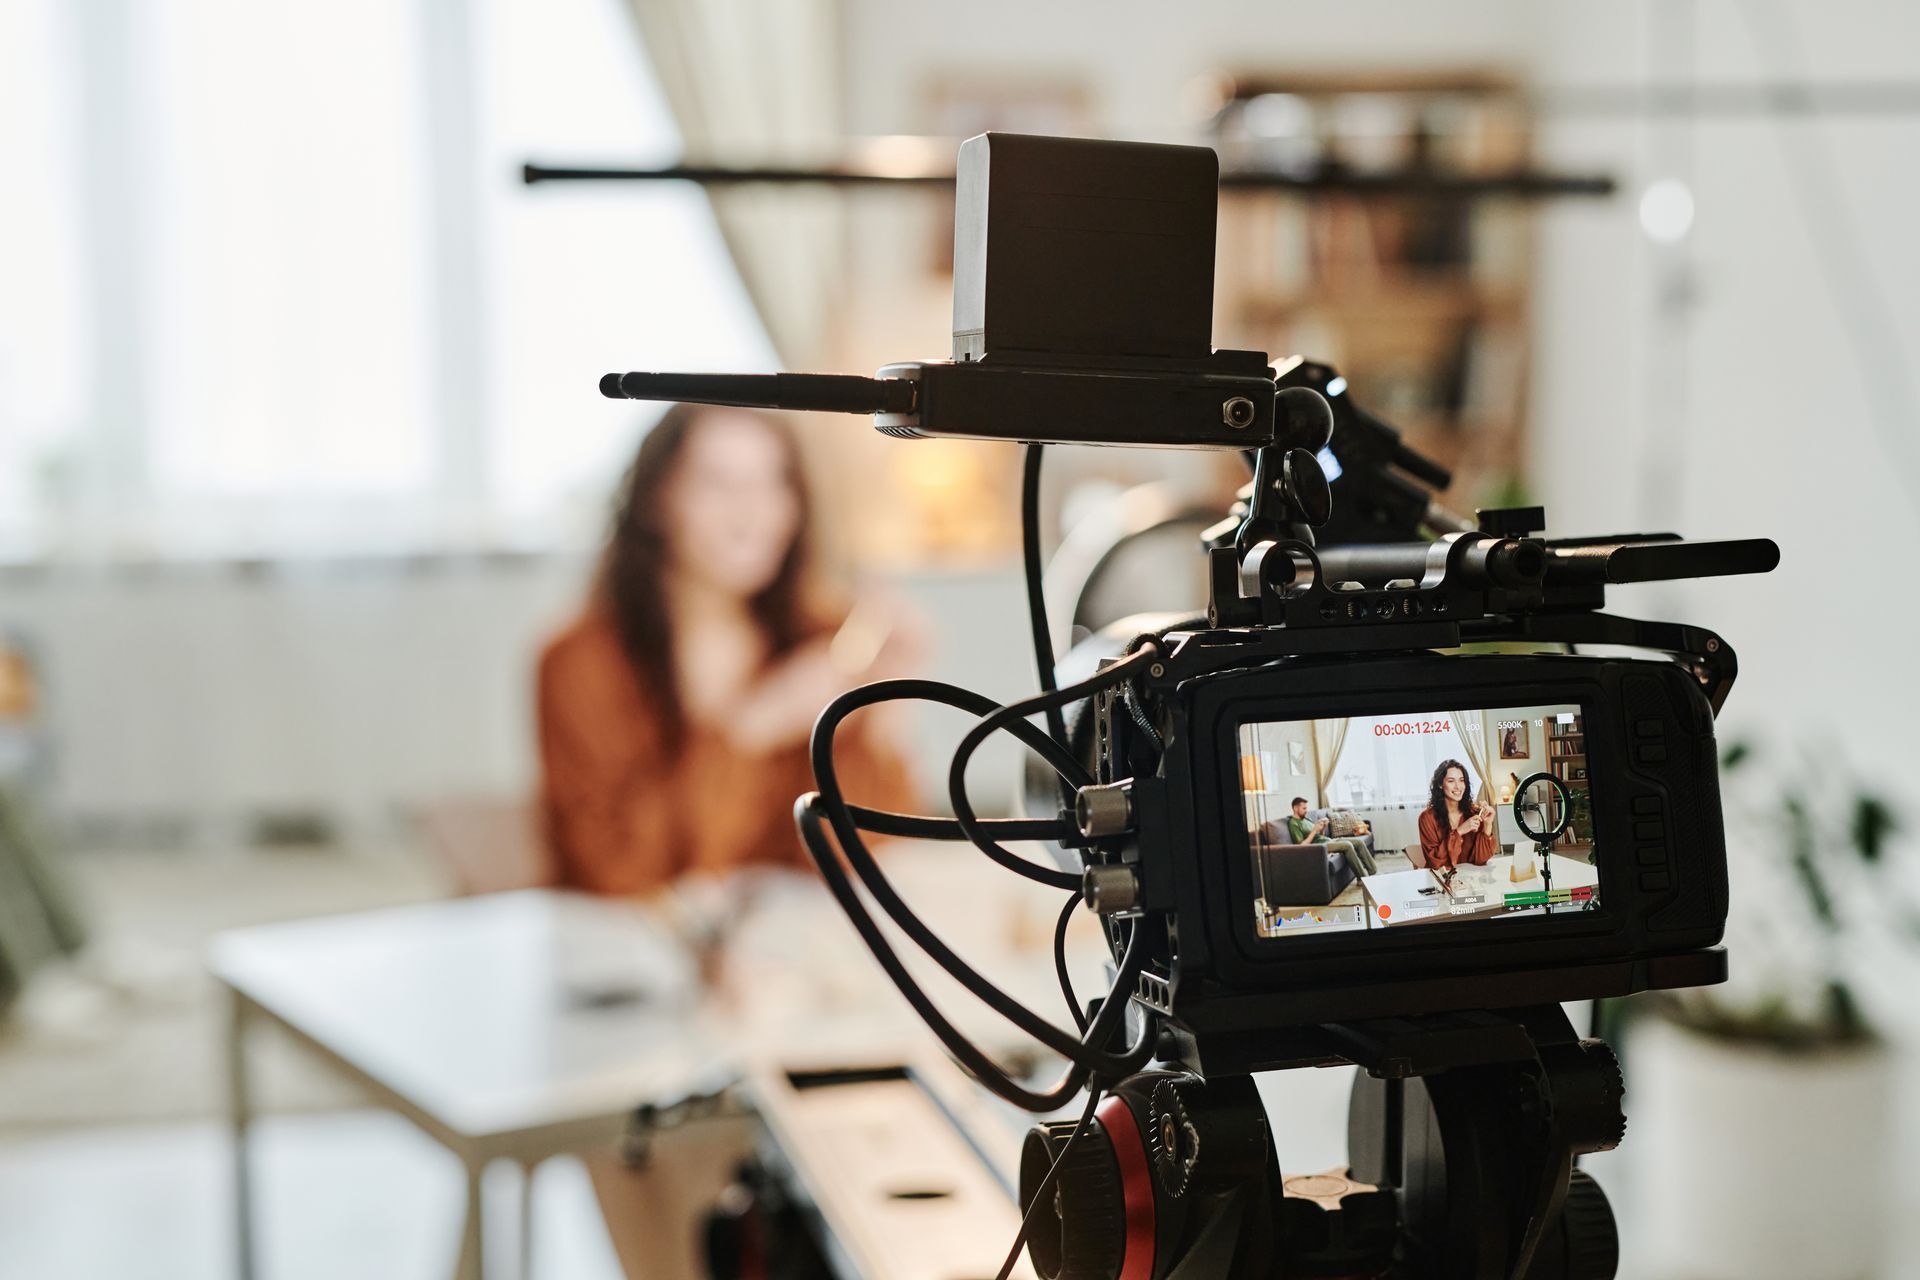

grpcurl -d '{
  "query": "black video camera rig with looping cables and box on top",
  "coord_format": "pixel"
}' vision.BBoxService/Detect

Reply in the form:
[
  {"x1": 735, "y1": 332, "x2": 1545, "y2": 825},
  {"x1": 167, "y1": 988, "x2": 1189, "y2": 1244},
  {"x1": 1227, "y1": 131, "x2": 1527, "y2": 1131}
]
[{"x1": 601, "y1": 134, "x2": 1778, "y2": 1280}]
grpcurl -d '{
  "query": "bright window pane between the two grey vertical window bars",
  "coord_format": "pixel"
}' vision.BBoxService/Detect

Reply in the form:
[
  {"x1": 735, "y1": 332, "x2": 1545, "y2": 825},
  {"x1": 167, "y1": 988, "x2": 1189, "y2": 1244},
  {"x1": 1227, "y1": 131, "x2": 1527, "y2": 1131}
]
[{"x1": 138, "y1": 0, "x2": 436, "y2": 503}]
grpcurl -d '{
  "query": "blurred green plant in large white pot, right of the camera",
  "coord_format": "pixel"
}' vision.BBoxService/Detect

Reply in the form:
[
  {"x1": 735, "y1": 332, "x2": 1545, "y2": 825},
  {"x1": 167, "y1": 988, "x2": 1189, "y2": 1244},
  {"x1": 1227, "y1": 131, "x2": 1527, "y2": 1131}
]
[{"x1": 1605, "y1": 743, "x2": 1920, "y2": 1280}]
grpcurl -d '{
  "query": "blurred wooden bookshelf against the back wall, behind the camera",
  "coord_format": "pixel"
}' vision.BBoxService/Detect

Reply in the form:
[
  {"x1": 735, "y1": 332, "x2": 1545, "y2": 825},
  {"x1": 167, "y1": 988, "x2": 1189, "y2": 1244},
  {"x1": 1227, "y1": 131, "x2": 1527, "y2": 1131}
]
[{"x1": 1210, "y1": 71, "x2": 1534, "y2": 509}]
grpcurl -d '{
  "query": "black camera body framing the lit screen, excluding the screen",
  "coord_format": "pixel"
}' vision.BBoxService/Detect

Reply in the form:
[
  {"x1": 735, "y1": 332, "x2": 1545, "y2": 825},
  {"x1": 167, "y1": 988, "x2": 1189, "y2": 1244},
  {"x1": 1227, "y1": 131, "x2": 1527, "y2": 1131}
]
[{"x1": 1083, "y1": 635, "x2": 1726, "y2": 1075}]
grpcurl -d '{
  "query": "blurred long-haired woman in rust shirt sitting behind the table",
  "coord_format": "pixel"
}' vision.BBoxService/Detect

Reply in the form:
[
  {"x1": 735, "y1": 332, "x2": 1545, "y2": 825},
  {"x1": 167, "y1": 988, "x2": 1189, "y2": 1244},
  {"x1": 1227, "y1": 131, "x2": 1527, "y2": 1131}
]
[{"x1": 540, "y1": 405, "x2": 912, "y2": 894}]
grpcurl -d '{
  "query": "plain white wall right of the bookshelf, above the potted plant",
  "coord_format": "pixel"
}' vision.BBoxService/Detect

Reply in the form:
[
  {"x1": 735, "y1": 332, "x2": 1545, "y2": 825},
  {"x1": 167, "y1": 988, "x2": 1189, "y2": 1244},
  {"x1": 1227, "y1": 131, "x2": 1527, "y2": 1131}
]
[{"x1": 1532, "y1": 0, "x2": 1920, "y2": 810}]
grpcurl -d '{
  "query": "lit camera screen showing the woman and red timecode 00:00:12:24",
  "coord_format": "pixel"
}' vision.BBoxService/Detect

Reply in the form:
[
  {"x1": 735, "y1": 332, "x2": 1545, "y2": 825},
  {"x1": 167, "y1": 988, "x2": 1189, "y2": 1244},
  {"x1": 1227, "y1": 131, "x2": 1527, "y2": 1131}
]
[{"x1": 1238, "y1": 704, "x2": 1599, "y2": 938}]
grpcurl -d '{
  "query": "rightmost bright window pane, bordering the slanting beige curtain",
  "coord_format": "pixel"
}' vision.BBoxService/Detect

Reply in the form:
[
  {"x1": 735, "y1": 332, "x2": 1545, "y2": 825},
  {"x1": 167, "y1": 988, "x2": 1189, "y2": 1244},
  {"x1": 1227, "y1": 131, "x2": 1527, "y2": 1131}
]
[{"x1": 482, "y1": 0, "x2": 778, "y2": 528}]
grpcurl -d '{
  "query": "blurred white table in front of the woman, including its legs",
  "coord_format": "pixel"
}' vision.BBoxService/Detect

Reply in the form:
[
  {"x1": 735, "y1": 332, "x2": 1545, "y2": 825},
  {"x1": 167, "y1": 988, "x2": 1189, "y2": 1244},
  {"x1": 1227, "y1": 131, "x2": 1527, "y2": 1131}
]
[{"x1": 211, "y1": 842, "x2": 1104, "y2": 1280}]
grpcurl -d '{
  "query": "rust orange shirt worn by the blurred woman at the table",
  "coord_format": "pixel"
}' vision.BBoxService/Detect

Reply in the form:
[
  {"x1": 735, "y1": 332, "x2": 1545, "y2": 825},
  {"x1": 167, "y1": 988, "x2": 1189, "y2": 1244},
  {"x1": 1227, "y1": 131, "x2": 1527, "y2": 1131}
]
[{"x1": 538, "y1": 612, "x2": 914, "y2": 894}]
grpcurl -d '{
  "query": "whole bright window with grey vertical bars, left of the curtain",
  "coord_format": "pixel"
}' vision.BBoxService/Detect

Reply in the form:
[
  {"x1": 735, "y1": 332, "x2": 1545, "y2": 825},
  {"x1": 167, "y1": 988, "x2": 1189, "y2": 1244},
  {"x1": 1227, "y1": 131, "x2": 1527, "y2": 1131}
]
[{"x1": 0, "y1": 0, "x2": 774, "y2": 555}]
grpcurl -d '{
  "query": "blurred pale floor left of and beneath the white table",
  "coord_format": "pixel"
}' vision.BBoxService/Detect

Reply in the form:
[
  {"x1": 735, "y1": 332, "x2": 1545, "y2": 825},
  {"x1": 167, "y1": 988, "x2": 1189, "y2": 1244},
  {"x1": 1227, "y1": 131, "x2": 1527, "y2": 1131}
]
[{"x1": 0, "y1": 844, "x2": 620, "y2": 1280}]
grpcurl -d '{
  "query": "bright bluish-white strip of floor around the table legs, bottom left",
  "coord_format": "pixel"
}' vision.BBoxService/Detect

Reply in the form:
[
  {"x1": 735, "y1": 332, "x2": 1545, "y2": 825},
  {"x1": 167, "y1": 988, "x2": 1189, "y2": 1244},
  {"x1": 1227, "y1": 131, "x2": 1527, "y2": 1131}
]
[{"x1": 0, "y1": 1111, "x2": 620, "y2": 1280}]
